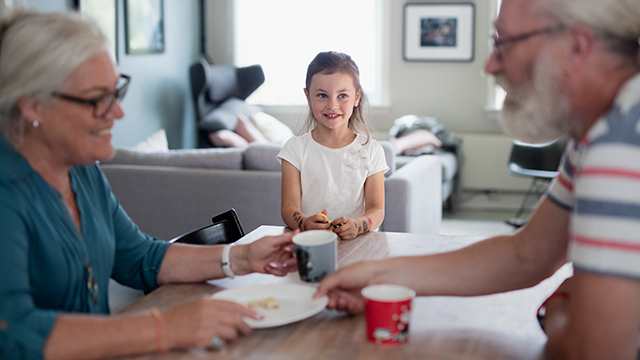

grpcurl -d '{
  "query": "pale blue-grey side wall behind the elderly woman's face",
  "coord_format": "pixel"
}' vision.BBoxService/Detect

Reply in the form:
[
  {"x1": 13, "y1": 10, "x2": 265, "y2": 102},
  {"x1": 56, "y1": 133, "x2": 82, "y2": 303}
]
[{"x1": 13, "y1": 0, "x2": 200, "y2": 148}]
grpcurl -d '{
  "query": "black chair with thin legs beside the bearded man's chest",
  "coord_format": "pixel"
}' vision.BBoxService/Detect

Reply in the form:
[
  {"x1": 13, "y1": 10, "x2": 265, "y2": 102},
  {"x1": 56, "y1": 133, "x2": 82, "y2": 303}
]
[{"x1": 505, "y1": 136, "x2": 568, "y2": 228}]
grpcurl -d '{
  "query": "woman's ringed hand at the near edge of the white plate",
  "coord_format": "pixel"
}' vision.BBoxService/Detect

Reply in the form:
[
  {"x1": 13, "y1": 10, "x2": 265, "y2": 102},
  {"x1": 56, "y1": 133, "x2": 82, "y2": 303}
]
[{"x1": 161, "y1": 296, "x2": 262, "y2": 349}]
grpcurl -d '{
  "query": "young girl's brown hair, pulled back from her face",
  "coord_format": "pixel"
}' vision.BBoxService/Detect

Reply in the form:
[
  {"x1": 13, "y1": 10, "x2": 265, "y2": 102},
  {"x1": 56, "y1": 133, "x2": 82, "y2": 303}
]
[{"x1": 304, "y1": 51, "x2": 371, "y2": 144}]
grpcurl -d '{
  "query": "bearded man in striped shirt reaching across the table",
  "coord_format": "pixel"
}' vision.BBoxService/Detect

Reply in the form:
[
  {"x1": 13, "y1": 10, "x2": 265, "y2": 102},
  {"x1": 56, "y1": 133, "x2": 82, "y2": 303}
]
[{"x1": 317, "y1": 0, "x2": 640, "y2": 359}]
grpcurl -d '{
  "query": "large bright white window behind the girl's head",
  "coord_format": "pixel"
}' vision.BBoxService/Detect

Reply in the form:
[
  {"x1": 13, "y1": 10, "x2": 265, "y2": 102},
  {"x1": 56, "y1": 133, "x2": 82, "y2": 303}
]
[{"x1": 233, "y1": 0, "x2": 385, "y2": 106}]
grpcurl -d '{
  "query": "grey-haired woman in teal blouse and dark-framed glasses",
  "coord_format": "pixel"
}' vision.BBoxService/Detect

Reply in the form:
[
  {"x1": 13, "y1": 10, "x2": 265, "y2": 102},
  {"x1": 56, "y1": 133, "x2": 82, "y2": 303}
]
[{"x1": 0, "y1": 11, "x2": 295, "y2": 359}]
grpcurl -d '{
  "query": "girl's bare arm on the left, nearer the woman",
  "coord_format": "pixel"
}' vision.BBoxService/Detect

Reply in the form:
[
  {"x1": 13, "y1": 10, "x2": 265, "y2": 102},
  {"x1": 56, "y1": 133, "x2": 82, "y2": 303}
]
[{"x1": 280, "y1": 159, "x2": 330, "y2": 231}]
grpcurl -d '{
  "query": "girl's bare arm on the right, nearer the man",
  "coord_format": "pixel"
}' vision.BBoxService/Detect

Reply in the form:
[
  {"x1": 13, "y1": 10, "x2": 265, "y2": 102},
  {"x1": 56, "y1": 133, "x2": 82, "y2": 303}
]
[{"x1": 333, "y1": 171, "x2": 384, "y2": 240}]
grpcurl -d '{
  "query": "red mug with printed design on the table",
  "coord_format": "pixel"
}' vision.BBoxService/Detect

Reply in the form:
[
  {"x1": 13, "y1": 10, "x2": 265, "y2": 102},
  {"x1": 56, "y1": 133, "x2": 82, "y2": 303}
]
[{"x1": 362, "y1": 284, "x2": 416, "y2": 345}]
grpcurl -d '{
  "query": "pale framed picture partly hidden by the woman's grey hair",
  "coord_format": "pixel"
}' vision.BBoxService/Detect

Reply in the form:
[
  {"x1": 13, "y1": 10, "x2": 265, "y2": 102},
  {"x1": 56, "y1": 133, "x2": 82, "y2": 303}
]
[{"x1": 74, "y1": 0, "x2": 118, "y2": 63}]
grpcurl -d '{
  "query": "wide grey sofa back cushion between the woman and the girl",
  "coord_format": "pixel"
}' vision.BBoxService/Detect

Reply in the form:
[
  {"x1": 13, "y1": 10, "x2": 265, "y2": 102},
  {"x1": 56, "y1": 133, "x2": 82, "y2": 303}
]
[{"x1": 104, "y1": 147, "x2": 242, "y2": 170}]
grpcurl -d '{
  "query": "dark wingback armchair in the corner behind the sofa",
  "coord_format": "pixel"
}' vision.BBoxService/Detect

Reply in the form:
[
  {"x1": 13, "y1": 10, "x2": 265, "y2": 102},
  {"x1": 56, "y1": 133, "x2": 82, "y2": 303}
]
[{"x1": 189, "y1": 59, "x2": 264, "y2": 147}]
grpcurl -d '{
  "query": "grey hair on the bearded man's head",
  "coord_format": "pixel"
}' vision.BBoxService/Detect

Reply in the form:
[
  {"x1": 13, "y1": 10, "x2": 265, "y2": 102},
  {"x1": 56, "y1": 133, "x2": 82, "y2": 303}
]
[{"x1": 540, "y1": 0, "x2": 640, "y2": 68}]
